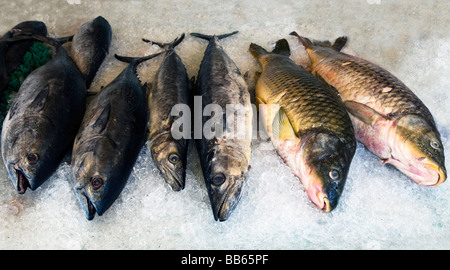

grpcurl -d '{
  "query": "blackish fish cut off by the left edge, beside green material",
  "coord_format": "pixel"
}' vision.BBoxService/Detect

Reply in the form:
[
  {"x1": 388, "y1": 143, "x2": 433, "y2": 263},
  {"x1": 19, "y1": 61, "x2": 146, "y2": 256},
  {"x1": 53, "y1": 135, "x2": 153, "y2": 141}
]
[{"x1": 0, "y1": 21, "x2": 47, "y2": 95}]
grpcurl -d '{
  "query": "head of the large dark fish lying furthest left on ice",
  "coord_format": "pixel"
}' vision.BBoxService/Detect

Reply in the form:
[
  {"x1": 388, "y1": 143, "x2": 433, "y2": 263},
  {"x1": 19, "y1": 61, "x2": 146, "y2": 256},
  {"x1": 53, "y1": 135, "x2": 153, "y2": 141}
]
[{"x1": 2, "y1": 121, "x2": 57, "y2": 194}]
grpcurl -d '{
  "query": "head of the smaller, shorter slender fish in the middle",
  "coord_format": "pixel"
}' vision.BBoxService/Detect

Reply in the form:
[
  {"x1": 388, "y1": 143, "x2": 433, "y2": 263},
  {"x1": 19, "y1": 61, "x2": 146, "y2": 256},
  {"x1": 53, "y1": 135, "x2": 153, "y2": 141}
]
[{"x1": 149, "y1": 133, "x2": 187, "y2": 191}]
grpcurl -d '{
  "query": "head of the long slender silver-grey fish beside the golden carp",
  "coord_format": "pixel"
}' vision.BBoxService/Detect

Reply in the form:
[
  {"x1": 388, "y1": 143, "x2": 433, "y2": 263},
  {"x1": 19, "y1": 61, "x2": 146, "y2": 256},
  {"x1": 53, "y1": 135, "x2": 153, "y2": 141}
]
[{"x1": 205, "y1": 143, "x2": 249, "y2": 221}]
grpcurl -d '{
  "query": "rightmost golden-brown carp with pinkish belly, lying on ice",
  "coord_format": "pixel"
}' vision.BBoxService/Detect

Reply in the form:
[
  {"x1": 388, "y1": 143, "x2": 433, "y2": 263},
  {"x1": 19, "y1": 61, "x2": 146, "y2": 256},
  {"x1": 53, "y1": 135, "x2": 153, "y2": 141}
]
[{"x1": 291, "y1": 32, "x2": 447, "y2": 186}]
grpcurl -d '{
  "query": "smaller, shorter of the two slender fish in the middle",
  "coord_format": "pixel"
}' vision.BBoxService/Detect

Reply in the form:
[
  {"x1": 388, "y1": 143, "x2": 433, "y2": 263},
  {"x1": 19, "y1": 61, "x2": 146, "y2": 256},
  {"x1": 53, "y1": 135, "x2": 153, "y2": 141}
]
[{"x1": 144, "y1": 34, "x2": 192, "y2": 191}]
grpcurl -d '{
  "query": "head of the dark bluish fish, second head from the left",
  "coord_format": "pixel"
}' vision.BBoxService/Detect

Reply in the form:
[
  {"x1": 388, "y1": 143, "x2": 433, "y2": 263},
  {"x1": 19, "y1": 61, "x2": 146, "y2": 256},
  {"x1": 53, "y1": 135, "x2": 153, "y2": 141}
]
[{"x1": 72, "y1": 151, "x2": 122, "y2": 220}]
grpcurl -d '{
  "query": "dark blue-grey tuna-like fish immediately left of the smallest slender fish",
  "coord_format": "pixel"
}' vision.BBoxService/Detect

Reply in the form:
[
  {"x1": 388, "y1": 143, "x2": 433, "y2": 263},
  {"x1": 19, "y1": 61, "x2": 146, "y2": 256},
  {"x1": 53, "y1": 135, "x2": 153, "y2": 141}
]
[{"x1": 71, "y1": 50, "x2": 161, "y2": 220}]
